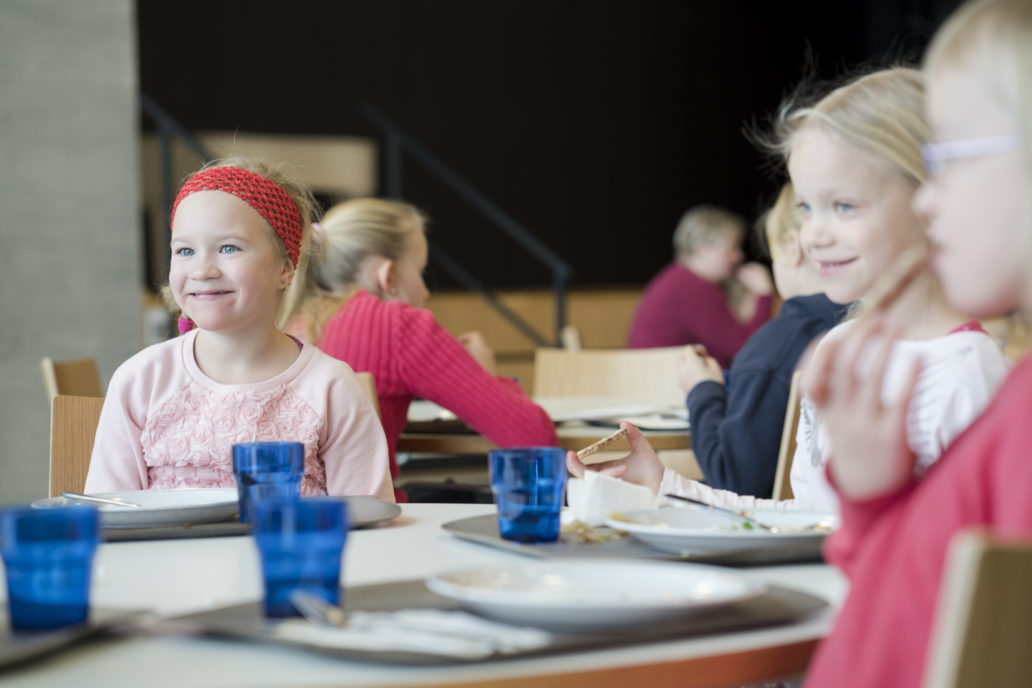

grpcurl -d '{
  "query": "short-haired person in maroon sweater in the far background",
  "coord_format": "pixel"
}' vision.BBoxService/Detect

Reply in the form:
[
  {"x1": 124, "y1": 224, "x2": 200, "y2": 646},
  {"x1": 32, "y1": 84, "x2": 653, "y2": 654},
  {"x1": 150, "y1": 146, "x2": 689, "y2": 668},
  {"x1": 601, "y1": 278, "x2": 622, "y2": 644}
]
[{"x1": 627, "y1": 205, "x2": 773, "y2": 368}]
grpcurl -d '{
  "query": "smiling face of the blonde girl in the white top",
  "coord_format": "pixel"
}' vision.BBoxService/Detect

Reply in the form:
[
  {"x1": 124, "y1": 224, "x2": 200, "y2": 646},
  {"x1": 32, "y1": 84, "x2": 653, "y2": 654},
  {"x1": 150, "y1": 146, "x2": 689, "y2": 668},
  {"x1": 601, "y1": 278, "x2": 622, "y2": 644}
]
[{"x1": 788, "y1": 125, "x2": 928, "y2": 303}]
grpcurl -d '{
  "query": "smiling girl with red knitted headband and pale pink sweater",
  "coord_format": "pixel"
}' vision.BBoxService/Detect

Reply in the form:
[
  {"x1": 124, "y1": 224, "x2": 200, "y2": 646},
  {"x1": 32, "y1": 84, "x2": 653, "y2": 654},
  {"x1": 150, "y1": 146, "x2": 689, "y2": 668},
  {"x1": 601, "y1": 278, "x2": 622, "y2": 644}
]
[{"x1": 86, "y1": 158, "x2": 393, "y2": 500}]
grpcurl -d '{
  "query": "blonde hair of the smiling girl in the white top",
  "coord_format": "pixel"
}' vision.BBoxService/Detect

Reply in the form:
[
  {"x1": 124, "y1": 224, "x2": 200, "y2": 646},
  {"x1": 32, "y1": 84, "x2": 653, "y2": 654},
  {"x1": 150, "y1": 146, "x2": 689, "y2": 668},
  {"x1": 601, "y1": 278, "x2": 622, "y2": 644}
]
[{"x1": 767, "y1": 67, "x2": 928, "y2": 185}]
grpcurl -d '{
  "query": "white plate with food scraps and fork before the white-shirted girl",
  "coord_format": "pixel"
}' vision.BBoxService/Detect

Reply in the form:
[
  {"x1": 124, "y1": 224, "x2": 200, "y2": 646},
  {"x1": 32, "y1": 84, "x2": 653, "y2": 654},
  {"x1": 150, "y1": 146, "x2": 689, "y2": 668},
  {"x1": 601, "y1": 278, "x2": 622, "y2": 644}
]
[{"x1": 606, "y1": 504, "x2": 839, "y2": 554}]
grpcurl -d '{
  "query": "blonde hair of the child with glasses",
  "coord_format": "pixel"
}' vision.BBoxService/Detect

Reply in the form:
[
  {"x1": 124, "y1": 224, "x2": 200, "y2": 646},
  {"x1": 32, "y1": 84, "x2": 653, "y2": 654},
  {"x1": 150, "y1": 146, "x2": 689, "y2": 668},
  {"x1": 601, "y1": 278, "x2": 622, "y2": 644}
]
[{"x1": 925, "y1": 0, "x2": 1032, "y2": 177}]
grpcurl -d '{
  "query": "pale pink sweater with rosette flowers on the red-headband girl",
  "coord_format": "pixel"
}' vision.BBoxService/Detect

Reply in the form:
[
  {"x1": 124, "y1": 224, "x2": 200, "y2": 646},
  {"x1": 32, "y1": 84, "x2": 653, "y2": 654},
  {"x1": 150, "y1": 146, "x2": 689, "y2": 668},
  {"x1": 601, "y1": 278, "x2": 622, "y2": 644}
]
[{"x1": 86, "y1": 330, "x2": 394, "y2": 501}]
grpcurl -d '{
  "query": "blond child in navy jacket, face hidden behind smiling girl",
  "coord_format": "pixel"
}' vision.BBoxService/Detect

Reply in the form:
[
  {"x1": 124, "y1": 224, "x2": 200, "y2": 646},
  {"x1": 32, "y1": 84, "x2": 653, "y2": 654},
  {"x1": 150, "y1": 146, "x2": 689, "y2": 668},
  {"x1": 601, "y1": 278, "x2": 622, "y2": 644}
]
[{"x1": 678, "y1": 184, "x2": 846, "y2": 497}]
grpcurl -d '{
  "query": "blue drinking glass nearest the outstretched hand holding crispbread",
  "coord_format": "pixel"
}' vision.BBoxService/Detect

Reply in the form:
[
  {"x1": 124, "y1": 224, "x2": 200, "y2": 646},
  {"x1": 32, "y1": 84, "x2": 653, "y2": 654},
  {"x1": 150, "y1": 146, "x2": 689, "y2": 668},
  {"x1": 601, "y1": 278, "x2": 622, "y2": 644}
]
[{"x1": 488, "y1": 447, "x2": 567, "y2": 543}]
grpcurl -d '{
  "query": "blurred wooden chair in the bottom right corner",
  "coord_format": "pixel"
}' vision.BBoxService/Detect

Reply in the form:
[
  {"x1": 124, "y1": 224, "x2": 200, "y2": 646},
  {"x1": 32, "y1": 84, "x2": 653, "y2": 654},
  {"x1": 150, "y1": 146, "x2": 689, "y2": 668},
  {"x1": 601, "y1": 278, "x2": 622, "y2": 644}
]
[{"x1": 924, "y1": 530, "x2": 1032, "y2": 688}]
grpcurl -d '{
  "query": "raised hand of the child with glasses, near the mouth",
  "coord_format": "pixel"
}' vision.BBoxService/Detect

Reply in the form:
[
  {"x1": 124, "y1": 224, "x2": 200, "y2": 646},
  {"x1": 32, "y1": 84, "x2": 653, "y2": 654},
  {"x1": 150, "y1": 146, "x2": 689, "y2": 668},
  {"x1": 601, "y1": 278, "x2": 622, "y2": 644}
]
[{"x1": 803, "y1": 314, "x2": 921, "y2": 499}]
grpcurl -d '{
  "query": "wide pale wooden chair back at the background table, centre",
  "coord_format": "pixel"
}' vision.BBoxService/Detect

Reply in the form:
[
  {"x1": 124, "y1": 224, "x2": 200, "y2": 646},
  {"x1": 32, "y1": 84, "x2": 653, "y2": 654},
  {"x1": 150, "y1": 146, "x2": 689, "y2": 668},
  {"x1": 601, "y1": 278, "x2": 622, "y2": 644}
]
[{"x1": 534, "y1": 347, "x2": 685, "y2": 405}]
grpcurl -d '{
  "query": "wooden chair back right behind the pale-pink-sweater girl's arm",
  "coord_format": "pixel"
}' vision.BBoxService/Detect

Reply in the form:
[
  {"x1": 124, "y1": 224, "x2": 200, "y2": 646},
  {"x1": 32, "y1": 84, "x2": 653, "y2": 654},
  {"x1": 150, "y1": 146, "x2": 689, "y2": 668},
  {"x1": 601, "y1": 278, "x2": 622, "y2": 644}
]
[{"x1": 51, "y1": 394, "x2": 104, "y2": 497}]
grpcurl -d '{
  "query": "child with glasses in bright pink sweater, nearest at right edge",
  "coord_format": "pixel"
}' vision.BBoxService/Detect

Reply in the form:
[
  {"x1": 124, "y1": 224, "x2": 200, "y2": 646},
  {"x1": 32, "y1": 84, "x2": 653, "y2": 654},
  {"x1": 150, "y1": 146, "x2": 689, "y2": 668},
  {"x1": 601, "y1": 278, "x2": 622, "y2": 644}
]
[{"x1": 803, "y1": 0, "x2": 1032, "y2": 688}]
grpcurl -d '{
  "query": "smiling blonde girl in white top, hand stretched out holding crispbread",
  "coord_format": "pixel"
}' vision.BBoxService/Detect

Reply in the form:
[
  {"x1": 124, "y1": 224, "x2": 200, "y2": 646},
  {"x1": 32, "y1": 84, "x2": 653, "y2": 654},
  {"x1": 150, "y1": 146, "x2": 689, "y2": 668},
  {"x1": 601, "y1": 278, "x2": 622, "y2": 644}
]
[{"x1": 568, "y1": 67, "x2": 1009, "y2": 513}]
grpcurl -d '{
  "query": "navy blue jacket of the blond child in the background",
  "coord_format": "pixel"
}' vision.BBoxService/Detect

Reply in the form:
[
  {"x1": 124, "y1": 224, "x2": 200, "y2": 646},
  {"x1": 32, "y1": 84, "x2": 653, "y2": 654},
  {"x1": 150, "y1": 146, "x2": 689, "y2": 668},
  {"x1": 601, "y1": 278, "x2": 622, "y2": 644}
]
[{"x1": 687, "y1": 294, "x2": 848, "y2": 497}]
